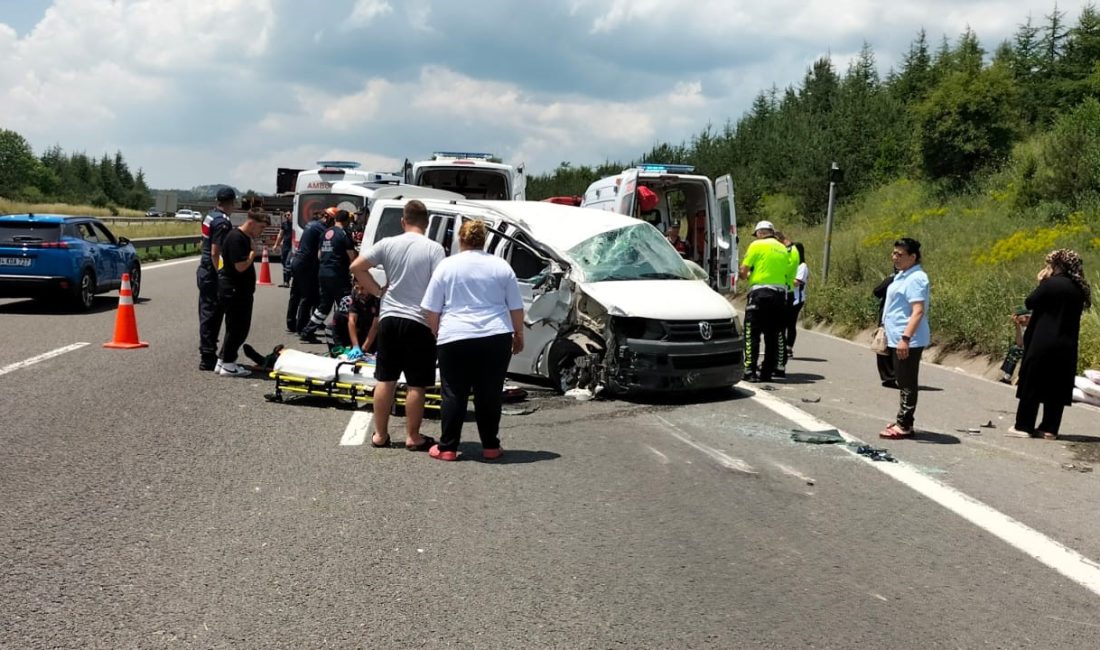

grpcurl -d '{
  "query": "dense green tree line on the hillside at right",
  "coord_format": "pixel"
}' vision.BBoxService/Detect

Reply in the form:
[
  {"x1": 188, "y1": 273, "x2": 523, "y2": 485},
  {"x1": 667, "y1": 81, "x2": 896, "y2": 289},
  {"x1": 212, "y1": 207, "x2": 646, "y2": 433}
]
[{"x1": 528, "y1": 4, "x2": 1100, "y2": 224}]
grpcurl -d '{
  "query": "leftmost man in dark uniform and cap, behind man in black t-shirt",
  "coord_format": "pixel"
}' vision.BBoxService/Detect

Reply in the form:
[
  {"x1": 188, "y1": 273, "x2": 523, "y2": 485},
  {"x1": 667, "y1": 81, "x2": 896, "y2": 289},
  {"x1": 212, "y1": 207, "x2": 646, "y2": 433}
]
[{"x1": 195, "y1": 187, "x2": 237, "y2": 371}]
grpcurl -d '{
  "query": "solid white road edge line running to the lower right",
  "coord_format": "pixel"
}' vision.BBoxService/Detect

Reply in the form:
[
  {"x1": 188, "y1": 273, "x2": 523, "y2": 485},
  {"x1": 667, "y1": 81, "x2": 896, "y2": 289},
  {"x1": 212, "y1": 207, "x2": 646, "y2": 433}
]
[{"x1": 750, "y1": 392, "x2": 1100, "y2": 596}]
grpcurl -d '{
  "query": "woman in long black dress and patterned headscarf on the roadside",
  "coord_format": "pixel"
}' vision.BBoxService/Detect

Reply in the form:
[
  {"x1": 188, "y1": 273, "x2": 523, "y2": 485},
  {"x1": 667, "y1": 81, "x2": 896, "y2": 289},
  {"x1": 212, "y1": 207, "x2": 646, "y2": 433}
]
[{"x1": 1010, "y1": 249, "x2": 1092, "y2": 440}]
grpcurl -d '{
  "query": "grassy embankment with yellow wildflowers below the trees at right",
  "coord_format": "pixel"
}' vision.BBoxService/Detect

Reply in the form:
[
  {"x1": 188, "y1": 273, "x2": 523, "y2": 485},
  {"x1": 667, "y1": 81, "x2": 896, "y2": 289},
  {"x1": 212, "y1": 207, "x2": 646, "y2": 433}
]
[{"x1": 770, "y1": 180, "x2": 1100, "y2": 368}]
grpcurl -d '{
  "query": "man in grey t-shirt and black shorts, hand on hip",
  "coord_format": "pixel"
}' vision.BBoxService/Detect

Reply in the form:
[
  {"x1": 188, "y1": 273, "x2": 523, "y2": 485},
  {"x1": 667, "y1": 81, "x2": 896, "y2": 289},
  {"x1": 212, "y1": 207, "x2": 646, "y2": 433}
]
[{"x1": 351, "y1": 200, "x2": 447, "y2": 451}]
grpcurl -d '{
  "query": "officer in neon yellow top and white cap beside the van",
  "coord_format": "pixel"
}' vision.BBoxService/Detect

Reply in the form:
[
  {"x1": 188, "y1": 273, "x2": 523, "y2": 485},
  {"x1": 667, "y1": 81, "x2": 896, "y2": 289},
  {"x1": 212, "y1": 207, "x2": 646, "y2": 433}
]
[{"x1": 738, "y1": 221, "x2": 791, "y2": 382}]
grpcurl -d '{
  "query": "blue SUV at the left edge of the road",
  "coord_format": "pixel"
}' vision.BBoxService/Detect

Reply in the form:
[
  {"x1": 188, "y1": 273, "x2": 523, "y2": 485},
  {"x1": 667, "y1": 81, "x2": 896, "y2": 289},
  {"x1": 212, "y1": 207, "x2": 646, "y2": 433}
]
[{"x1": 0, "y1": 214, "x2": 141, "y2": 310}]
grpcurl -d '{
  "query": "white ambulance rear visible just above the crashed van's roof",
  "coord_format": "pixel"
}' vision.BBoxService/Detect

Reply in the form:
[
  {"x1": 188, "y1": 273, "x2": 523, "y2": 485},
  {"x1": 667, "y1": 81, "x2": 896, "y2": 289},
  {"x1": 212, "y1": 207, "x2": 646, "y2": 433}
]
[{"x1": 405, "y1": 152, "x2": 527, "y2": 201}]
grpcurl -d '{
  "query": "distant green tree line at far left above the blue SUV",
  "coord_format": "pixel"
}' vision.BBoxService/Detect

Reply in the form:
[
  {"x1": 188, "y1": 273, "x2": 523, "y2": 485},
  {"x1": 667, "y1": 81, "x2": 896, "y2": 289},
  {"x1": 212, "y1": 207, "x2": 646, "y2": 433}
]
[{"x1": 0, "y1": 129, "x2": 153, "y2": 210}]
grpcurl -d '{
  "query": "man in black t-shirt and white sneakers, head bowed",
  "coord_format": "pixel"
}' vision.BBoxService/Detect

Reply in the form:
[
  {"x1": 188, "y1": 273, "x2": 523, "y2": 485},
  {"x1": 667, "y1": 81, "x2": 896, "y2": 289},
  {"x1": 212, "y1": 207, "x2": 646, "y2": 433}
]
[{"x1": 218, "y1": 208, "x2": 271, "y2": 377}]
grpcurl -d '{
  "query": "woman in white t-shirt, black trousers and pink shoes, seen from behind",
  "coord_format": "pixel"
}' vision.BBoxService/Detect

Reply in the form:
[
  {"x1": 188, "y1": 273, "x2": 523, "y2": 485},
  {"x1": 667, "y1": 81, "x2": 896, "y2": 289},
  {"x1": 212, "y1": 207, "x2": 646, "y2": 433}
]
[{"x1": 420, "y1": 221, "x2": 524, "y2": 461}]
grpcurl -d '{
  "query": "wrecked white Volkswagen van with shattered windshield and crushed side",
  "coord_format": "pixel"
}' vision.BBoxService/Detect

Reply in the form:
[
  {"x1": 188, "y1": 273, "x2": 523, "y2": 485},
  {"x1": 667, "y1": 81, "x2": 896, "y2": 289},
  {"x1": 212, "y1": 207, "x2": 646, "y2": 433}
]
[{"x1": 363, "y1": 199, "x2": 745, "y2": 393}]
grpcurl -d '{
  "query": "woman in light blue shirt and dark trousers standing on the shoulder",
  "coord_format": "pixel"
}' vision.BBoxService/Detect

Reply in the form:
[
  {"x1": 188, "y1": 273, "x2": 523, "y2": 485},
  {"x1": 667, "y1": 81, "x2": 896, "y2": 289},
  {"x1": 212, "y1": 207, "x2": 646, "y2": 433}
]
[{"x1": 879, "y1": 238, "x2": 932, "y2": 439}]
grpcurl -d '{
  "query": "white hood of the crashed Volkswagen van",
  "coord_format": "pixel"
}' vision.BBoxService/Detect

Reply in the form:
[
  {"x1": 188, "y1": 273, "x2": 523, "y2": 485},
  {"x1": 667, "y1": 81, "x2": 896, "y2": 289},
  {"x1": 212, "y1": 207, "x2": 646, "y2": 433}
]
[{"x1": 580, "y1": 279, "x2": 736, "y2": 320}]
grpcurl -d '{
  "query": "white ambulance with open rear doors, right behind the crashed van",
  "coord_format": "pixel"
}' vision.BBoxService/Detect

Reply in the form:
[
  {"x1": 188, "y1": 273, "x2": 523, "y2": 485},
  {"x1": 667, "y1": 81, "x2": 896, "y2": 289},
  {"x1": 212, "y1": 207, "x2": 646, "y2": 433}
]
[{"x1": 581, "y1": 164, "x2": 738, "y2": 293}]
